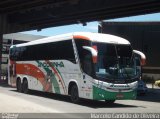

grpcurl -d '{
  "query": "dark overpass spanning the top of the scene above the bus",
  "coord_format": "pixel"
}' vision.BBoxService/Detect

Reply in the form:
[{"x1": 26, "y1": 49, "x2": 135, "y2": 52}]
[{"x1": 0, "y1": 0, "x2": 160, "y2": 33}]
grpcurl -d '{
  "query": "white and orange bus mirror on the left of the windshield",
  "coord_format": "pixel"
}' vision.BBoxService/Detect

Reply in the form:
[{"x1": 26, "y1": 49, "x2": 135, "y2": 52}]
[{"x1": 83, "y1": 46, "x2": 98, "y2": 64}]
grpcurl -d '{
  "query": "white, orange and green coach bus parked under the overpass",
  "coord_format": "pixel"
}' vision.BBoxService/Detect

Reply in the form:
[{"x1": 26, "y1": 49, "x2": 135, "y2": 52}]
[{"x1": 9, "y1": 32, "x2": 146, "y2": 104}]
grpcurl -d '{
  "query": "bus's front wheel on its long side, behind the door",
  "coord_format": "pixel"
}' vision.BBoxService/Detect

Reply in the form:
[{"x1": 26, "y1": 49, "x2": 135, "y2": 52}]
[{"x1": 70, "y1": 84, "x2": 80, "y2": 103}]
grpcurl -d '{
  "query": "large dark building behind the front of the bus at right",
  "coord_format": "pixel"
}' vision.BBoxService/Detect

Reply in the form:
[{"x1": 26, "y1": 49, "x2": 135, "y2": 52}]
[{"x1": 98, "y1": 22, "x2": 160, "y2": 80}]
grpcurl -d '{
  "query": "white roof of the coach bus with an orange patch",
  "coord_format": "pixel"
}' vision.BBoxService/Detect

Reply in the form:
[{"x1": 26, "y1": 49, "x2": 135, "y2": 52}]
[{"x1": 12, "y1": 32, "x2": 130, "y2": 47}]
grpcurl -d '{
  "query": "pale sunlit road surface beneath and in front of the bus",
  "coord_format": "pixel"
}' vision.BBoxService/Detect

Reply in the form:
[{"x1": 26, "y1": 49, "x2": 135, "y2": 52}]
[{"x1": 0, "y1": 85, "x2": 160, "y2": 117}]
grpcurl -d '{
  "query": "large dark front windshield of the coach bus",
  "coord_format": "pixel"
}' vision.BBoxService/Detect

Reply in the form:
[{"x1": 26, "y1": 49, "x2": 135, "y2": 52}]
[{"x1": 94, "y1": 43, "x2": 137, "y2": 80}]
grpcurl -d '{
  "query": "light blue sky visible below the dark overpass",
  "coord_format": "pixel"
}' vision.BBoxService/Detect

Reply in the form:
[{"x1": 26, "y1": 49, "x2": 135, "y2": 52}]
[{"x1": 22, "y1": 13, "x2": 160, "y2": 36}]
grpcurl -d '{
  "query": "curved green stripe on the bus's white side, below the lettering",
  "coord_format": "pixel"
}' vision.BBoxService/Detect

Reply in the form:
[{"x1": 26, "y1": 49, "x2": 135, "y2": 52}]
[{"x1": 36, "y1": 61, "x2": 60, "y2": 94}]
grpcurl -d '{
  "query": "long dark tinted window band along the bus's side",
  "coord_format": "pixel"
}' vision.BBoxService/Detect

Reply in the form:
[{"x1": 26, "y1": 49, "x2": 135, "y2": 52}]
[{"x1": 10, "y1": 40, "x2": 75, "y2": 63}]
